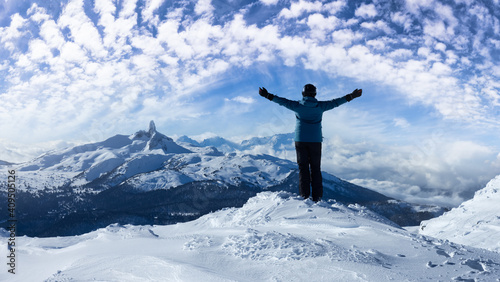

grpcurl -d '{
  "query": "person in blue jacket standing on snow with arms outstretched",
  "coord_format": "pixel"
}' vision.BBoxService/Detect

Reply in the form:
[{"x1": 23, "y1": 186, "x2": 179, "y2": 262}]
[{"x1": 259, "y1": 84, "x2": 363, "y2": 202}]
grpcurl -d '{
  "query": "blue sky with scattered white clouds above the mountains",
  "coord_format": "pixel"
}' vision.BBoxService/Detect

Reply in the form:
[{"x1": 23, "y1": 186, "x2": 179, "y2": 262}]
[{"x1": 0, "y1": 0, "x2": 500, "y2": 205}]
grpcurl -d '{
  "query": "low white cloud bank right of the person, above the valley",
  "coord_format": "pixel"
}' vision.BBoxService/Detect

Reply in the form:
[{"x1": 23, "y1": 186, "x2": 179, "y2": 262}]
[{"x1": 323, "y1": 133, "x2": 500, "y2": 205}]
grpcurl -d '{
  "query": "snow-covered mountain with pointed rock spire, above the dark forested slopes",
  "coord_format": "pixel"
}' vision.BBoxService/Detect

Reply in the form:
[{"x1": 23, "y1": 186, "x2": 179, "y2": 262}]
[{"x1": 11, "y1": 121, "x2": 295, "y2": 192}]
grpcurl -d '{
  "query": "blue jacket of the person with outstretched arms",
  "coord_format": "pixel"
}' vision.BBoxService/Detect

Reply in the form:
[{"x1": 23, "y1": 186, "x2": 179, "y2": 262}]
[{"x1": 272, "y1": 95, "x2": 347, "y2": 142}]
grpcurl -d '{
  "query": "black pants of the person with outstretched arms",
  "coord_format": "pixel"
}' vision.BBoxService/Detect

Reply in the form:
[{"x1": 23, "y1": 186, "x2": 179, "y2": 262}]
[{"x1": 295, "y1": 142, "x2": 323, "y2": 202}]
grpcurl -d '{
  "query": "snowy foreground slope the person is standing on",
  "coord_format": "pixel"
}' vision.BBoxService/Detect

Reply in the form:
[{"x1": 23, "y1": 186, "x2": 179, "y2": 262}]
[{"x1": 0, "y1": 192, "x2": 500, "y2": 281}]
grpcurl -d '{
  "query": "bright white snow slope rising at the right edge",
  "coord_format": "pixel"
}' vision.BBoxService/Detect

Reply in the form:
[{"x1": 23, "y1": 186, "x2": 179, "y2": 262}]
[{"x1": 419, "y1": 175, "x2": 500, "y2": 252}]
